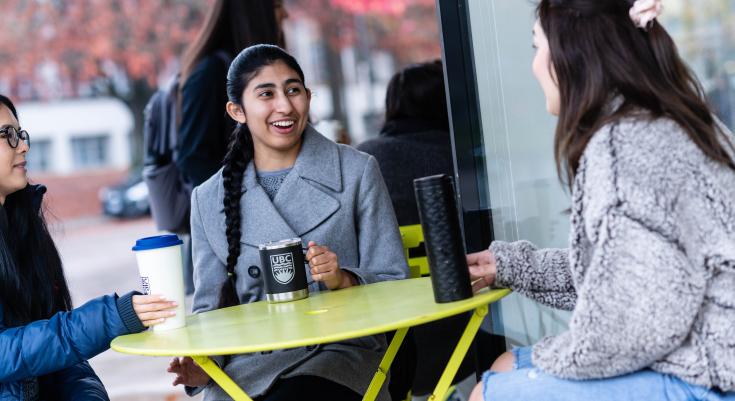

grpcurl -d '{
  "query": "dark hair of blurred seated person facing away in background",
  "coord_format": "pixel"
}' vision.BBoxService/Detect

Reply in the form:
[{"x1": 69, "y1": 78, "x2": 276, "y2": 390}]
[{"x1": 385, "y1": 60, "x2": 449, "y2": 130}]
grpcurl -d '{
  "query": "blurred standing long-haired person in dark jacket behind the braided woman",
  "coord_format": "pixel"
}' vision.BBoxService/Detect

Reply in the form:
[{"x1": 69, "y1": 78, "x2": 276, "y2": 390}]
[{"x1": 176, "y1": 0, "x2": 288, "y2": 294}]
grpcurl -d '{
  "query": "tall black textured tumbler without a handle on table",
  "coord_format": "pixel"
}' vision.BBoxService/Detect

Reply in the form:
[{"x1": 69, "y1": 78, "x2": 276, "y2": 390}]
[{"x1": 413, "y1": 174, "x2": 472, "y2": 303}]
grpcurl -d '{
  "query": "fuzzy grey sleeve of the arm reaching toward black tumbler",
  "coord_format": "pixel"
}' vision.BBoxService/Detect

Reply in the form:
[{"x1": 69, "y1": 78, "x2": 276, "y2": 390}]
[{"x1": 490, "y1": 241, "x2": 577, "y2": 310}]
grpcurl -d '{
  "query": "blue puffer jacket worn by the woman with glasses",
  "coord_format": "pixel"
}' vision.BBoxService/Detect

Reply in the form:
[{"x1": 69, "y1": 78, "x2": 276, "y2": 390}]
[{"x1": 0, "y1": 292, "x2": 144, "y2": 401}]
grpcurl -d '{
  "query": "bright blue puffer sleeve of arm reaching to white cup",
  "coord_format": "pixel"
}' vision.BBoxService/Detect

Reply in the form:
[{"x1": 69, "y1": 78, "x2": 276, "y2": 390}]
[{"x1": 0, "y1": 293, "x2": 143, "y2": 383}]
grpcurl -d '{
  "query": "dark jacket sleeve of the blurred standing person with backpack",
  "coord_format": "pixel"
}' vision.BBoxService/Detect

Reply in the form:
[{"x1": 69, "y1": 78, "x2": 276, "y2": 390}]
[{"x1": 176, "y1": 56, "x2": 229, "y2": 186}]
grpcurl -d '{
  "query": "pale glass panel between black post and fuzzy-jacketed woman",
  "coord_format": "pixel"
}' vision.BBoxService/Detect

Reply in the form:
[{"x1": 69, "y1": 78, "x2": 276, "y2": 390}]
[{"x1": 468, "y1": 0, "x2": 569, "y2": 344}]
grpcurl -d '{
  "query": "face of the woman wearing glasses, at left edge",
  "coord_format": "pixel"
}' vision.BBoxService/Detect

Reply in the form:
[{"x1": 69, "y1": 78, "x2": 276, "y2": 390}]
[{"x1": 0, "y1": 105, "x2": 28, "y2": 203}]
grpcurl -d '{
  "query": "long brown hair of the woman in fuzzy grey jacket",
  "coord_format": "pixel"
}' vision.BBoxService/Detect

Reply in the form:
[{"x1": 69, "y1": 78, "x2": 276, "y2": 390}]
[{"x1": 536, "y1": 0, "x2": 735, "y2": 187}]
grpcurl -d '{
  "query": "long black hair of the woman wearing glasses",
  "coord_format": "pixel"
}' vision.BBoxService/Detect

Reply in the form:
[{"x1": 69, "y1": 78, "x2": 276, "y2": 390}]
[{"x1": 0, "y1": 95, "x2": 72, "y2": 326}]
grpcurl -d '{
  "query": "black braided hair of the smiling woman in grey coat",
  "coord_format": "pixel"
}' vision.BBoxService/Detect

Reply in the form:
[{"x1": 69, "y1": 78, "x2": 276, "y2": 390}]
[{"x1": 219, "y1": 45, "x2": 306, "y2": 308}]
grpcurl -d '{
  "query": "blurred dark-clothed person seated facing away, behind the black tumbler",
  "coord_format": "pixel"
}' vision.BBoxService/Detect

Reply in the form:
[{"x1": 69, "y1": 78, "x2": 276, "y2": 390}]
[{"x1": 357, "y1": 60, "x2": 505, "y2": 399}]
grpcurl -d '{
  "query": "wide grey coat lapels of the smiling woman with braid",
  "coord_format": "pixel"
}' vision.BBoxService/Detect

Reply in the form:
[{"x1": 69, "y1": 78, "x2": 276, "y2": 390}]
[{"x1": 217, "y1": 126, "x2": 342, "y2": 246}]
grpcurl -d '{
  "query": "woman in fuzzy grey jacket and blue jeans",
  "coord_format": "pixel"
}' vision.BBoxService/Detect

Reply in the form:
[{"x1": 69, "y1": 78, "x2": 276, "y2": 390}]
[{"x1": 468, "y1": 0, "x2": 735, "y2": 401}]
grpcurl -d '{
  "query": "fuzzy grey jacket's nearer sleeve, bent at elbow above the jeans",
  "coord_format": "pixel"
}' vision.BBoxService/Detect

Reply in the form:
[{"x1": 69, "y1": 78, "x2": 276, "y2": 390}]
[{"x1": 533, "y1": 198, "x2": 706, "y2": 379}]
